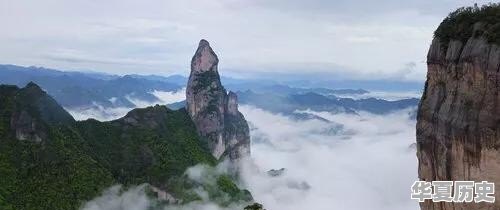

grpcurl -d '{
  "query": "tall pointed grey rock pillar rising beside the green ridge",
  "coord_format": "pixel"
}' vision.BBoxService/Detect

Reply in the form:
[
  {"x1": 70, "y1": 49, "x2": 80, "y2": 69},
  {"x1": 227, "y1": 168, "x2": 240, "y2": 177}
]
[{"x1": 186, "y1": 40, "x2": 250, "y2": 160}]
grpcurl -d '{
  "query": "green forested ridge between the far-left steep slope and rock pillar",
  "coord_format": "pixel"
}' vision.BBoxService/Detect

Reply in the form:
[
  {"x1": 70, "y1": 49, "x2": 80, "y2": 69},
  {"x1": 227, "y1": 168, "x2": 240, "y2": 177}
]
[{"x1": 78, "y1": 106, "x2": 216, "y2": 186}]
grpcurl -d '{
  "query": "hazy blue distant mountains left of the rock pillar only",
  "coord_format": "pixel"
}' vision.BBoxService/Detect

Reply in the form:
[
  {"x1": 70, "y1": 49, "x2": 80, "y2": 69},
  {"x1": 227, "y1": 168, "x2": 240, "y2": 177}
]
[{"x1": 0, "y1": 65, "x2": 185, "y2": 107}]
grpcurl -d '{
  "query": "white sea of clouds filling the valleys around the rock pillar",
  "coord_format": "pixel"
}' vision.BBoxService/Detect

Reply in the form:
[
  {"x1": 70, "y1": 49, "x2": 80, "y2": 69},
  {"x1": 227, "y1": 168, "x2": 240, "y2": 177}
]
[{"x1": 70, "y1": 91, "x2": 418, "y2": 210}]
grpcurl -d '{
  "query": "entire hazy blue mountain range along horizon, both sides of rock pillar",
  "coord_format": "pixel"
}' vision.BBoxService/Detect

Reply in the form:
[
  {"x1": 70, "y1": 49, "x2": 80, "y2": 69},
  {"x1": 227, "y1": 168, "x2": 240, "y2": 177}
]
[{"x1": 0, "y1": 65, "x2": 419, "y2": 119}]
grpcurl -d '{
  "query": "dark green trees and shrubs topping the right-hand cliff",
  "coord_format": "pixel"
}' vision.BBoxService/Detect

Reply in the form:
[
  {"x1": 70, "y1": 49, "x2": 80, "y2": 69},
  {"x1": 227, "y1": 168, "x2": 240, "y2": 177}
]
[{"x1": 434, "y1": 3, "x2": 500, "y2": 47}]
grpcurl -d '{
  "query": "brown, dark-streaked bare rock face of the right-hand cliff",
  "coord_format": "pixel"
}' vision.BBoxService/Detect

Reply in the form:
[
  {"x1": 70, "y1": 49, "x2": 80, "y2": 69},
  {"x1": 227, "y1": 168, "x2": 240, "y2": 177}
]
[{"x1": 417, "y1": 11, "x2": 500, "y2": 210}]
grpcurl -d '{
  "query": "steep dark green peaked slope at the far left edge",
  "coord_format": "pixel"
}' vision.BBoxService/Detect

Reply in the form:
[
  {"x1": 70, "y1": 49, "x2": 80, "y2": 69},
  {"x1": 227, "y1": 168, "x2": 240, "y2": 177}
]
[{"x1": 0, "y1": 83, "x2": 113, "y2": 210}]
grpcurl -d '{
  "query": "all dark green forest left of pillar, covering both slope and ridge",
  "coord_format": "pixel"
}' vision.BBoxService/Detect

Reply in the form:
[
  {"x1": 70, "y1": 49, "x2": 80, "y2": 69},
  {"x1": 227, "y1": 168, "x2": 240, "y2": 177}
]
[{"x1": 0, "y1": 84, "x2": 251, "y2": 210}]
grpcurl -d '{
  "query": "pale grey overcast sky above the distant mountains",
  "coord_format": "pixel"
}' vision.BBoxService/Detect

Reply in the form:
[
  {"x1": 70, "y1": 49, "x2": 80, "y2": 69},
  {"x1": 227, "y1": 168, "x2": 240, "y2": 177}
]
[{"x1": 0, "y1": 0, "x2": 492, "y2": 81}]
